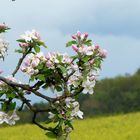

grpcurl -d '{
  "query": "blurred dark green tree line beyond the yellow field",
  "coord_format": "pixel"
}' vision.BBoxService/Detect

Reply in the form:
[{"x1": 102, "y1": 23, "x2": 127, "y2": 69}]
[{"x1": 13, "y1": 69, "x2": 140, "y2": 123}]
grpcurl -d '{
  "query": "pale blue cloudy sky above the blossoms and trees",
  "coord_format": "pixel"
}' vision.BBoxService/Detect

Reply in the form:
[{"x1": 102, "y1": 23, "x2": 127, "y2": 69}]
[{"x1": 0, "y1": 0, "x2": 140, "y2": 78}]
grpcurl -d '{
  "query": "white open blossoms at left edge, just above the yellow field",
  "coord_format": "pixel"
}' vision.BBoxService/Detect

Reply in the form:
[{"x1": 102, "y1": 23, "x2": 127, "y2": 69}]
[{"x1": 0, "y1": 110, "x2": 20, "y2": 125}]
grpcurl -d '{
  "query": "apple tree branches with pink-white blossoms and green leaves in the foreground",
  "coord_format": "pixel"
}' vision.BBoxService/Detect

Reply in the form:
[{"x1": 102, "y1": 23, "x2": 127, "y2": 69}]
[{"x1": 0, "y1": 24, "x2": 107, "y2": 140}]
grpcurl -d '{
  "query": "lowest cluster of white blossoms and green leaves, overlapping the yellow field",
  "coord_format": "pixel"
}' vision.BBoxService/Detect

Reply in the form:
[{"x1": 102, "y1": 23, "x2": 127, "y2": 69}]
[{"x1": 48, "y1": 97, "x2": 84, "y2": 133}]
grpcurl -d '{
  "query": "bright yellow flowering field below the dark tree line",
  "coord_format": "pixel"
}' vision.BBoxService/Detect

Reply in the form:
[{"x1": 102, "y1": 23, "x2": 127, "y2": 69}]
[{"x1": 0, "y1": 112, "x2": 140, "y2": 140}]
